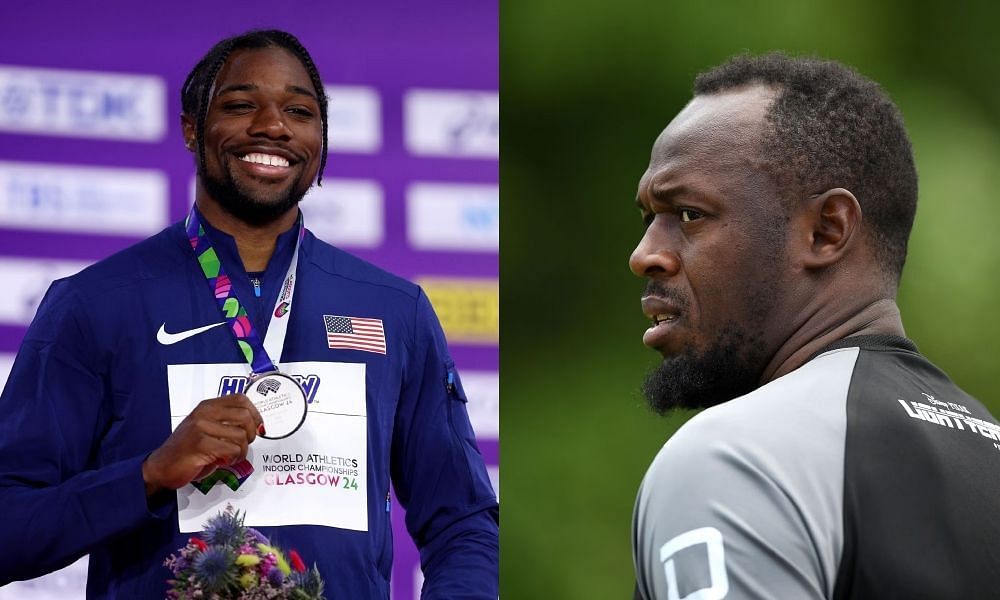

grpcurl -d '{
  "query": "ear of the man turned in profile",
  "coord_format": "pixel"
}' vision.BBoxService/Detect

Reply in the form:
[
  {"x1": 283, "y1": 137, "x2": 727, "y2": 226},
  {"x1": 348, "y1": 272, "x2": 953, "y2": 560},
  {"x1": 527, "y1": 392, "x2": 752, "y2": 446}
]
[{"x1": 801, "y1": 188, "x2": 861, "y2": 269}]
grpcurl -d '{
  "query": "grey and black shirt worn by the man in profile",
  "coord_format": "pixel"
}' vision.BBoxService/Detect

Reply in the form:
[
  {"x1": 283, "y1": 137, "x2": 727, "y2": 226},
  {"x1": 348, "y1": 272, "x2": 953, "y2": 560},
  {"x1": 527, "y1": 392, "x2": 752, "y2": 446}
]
[{"x1": 632, "y1": 336, "x2": 1000, "y2": 600}]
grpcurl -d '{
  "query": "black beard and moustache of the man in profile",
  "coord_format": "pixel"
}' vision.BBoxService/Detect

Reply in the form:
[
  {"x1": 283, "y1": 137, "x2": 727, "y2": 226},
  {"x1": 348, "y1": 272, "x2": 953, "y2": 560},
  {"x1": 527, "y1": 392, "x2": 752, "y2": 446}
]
[{"x1": 642, "y1": 281, "x2": 776, "y2": 415}]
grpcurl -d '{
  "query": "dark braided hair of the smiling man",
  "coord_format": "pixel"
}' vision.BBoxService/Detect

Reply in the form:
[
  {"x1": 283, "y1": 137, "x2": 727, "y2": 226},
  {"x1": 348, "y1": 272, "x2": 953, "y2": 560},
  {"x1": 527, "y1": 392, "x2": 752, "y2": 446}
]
[{"x1": 181, "y1": 29, "x2": 327, "y2": 185}]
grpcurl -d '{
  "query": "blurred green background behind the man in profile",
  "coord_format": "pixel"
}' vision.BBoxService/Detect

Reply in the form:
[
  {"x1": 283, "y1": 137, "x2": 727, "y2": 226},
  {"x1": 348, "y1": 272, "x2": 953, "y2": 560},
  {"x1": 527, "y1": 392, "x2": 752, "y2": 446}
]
[{"x1": 500, "y1": 0, "x2": 1000, "y2": 599}]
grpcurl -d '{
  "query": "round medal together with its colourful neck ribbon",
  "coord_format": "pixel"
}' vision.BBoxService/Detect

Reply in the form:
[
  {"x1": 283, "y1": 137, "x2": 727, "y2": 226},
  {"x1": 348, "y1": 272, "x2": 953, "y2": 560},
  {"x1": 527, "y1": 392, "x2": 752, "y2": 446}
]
[{"x1": 185, "y1": 206, "x2": 308, "y2": 494}]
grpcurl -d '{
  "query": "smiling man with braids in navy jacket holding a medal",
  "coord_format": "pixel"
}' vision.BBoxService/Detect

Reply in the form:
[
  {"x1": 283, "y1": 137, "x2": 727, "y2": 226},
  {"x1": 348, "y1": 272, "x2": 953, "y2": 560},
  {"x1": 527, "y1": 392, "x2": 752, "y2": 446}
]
[{"x1": 0, "y1": 31, "x2": 499, "y2": 600}]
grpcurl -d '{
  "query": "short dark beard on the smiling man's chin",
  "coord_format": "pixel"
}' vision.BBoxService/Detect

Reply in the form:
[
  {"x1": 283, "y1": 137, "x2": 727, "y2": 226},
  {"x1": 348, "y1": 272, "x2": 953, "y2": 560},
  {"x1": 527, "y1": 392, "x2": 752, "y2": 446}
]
[{"x1": 198, "y1": 155, "x2": 308, "y2": 227}]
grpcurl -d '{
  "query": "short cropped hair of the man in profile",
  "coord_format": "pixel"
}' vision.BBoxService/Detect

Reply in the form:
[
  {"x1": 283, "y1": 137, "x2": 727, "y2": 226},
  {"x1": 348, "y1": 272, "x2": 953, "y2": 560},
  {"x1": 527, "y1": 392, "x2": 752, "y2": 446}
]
[{"x1": 694, "y1": 52, "x2": 917, "y2": 281}]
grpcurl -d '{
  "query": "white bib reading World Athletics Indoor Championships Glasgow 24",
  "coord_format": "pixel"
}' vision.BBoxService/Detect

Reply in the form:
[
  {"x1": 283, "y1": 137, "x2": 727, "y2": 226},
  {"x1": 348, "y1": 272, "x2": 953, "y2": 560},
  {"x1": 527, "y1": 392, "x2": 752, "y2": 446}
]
[{"x1": 167, "y1": 362, "x2": 368, "y2": 533}]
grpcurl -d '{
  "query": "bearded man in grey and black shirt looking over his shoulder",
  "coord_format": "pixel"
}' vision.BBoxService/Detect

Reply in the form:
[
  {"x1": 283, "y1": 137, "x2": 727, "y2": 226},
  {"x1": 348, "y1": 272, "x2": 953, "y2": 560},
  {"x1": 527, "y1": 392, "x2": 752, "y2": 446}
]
[{"x1": 630, "y1": 54, "x2": 1000, "y2": 600}]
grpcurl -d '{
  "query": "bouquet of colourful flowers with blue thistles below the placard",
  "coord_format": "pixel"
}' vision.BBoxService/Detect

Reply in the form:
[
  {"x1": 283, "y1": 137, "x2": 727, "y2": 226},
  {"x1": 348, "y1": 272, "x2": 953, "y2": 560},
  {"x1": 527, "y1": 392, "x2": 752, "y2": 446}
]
[{"x1": 163, "y1": 508, "x2": 325, "y2": 600}]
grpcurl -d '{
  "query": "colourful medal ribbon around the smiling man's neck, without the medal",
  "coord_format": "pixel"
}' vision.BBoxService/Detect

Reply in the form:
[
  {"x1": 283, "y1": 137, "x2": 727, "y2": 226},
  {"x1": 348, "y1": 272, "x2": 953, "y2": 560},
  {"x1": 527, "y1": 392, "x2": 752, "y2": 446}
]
[{"x1": 184, "y1": 206, "x2": 306, "y2": 375}]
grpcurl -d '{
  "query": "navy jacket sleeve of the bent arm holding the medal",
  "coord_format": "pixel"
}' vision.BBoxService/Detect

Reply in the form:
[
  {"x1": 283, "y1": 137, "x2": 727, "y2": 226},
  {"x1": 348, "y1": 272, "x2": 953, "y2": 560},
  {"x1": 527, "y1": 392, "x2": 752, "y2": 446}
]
[{"x1": 0, "y1": 280, "x2": 166, "y2": 585}]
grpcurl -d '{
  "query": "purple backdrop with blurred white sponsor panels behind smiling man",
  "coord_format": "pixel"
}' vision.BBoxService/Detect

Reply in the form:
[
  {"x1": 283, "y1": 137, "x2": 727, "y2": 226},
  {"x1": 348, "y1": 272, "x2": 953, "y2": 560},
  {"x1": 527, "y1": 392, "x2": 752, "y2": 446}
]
[{"x1": 0, "y1": 0, "x2": 500, "y2": 600}]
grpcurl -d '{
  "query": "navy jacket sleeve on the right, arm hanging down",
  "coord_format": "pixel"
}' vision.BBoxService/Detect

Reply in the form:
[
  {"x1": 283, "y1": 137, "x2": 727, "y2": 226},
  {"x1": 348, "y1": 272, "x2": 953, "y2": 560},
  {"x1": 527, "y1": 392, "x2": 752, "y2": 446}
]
[{"x1": 391, "y1": 290, "x2": 500, "y2": 600}]
